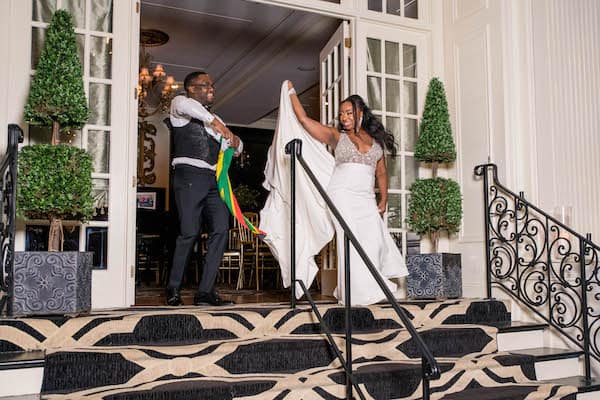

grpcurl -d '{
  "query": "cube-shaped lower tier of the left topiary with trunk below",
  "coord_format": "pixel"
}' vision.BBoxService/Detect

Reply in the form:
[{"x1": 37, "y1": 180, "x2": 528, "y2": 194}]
[{"x1": 17, "y1": 144, "x2": 94, "y2": 251}]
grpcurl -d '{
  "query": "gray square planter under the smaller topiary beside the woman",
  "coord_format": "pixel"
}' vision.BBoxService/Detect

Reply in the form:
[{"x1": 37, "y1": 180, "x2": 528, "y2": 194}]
[{"x1": 406, "y1": 253, "x2": 462, "y2": 299}]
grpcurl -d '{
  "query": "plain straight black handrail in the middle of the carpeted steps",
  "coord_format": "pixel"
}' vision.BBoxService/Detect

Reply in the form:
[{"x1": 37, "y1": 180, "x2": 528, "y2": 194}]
[{"x1": 285, "y1": 139, "x2": 440, "y2": 400}]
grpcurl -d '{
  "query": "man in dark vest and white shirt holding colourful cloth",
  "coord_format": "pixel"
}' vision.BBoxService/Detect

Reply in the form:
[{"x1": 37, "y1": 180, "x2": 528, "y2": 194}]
[{"x1": 167, "y1": 71, "x2": 243, "y2": 306}]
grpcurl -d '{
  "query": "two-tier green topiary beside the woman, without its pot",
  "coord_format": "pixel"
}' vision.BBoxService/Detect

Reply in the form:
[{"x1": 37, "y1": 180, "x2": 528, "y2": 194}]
[{"x1": 406, "y1": 78, "x2": 462, "y2": 253}]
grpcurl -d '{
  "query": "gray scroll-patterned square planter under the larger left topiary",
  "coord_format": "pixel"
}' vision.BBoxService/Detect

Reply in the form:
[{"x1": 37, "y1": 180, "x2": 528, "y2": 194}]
[{"x1": 10, "y1": 251, "x2": 94, "y2": 316}]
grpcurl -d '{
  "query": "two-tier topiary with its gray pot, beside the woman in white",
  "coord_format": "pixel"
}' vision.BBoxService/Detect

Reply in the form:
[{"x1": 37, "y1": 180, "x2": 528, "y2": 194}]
[{"x1": 406, "y1": 78, "x2": 462, "y2": 298}]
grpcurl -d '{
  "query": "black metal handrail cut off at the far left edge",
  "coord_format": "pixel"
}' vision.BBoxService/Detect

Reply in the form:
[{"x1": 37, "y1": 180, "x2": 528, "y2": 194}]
[{"x1": 0, "y1": 124, "x2": 23, "y2": 315}]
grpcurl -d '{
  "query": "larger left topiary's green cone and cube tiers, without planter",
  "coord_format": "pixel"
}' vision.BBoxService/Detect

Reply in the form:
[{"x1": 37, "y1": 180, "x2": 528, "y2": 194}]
[{"x1": 17, "y1": 10, "x2": 93, "y2": 251}]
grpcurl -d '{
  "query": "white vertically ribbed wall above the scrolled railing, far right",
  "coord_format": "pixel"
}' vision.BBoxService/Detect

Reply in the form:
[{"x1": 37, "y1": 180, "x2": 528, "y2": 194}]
[{"x1": 532, "y1": 0, "x2": 600, "y2": 238}]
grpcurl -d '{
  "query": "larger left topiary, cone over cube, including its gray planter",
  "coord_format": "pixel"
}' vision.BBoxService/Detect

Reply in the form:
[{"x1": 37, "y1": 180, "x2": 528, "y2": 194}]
[{"x1": 11, "y1": 10, "x2": 94, "y2": 315}]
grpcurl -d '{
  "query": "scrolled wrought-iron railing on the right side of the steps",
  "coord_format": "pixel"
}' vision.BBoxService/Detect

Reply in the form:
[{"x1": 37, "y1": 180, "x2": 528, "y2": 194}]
[{"x1": 474, "y1": 164, "x2": 600, "y2": 381}]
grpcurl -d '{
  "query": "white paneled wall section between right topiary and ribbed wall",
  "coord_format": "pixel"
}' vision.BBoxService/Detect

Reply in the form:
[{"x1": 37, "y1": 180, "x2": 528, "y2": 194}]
[{"x1": 443, "y1": 0, "x2": 506, "y2": 297}]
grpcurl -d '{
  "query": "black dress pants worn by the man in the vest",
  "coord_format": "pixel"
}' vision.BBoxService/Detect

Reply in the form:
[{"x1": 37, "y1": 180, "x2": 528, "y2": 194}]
[{"x1": 169, "y1": 165, "x2": 229, "y2": 293}]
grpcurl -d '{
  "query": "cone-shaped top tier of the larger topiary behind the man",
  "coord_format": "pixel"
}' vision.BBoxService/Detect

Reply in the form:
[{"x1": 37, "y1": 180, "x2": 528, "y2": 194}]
[{"x1": 24, "y1": 10, "x2": 89, "y2": 144}]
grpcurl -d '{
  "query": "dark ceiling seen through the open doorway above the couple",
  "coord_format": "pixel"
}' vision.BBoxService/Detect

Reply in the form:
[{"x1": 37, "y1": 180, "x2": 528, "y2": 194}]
[{"x1": 140, "y1": 0, "x2": 340, "y2": 125}]
